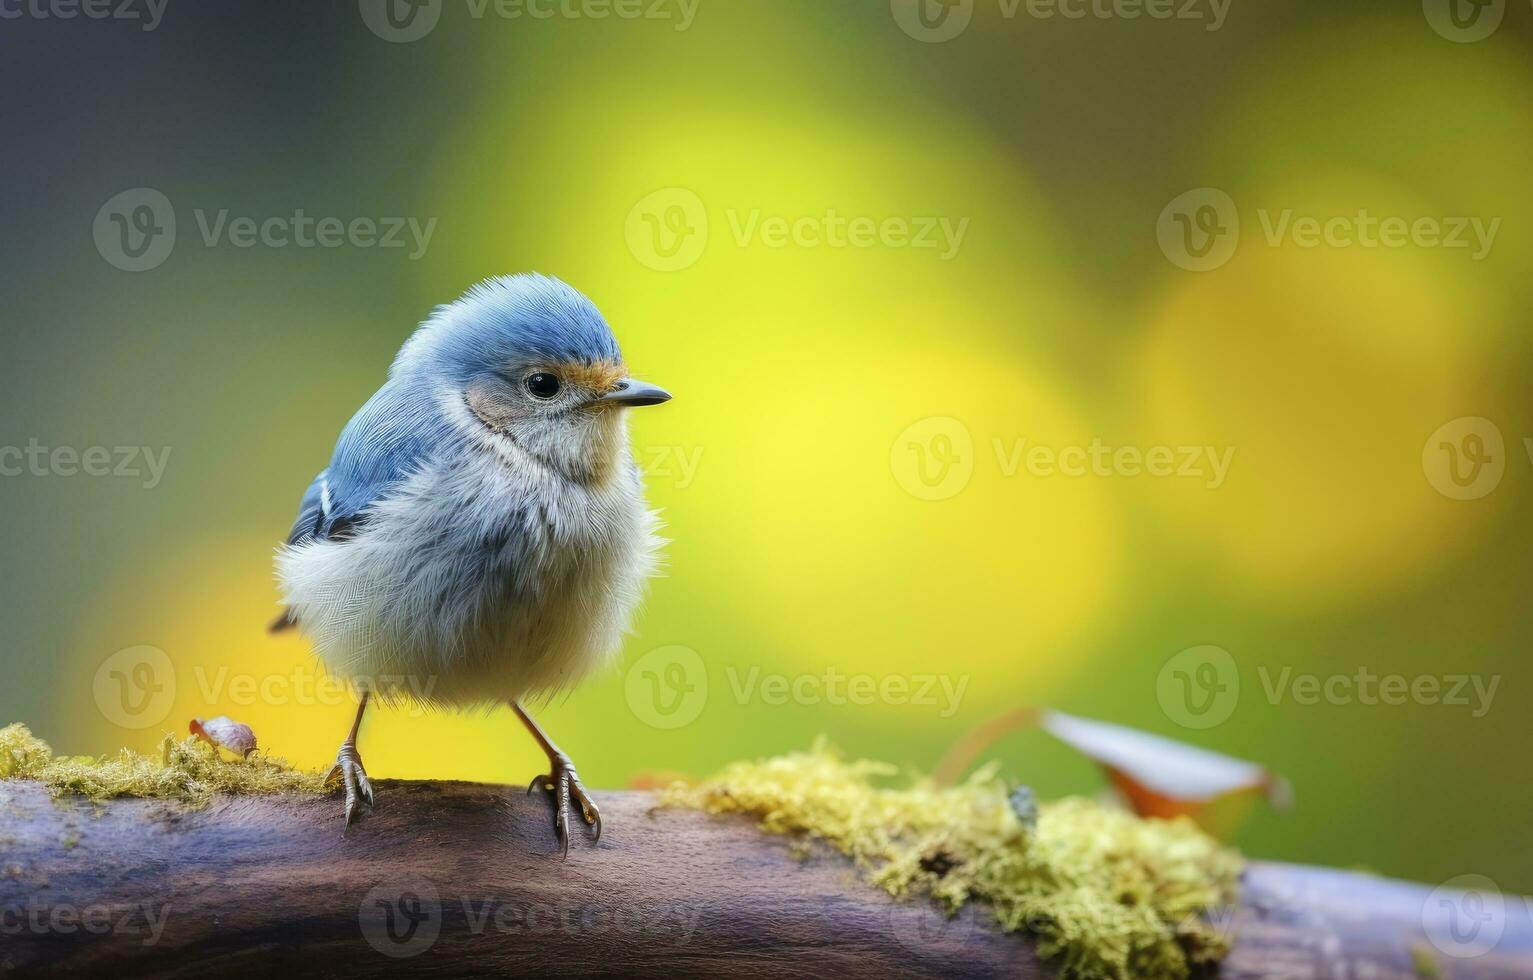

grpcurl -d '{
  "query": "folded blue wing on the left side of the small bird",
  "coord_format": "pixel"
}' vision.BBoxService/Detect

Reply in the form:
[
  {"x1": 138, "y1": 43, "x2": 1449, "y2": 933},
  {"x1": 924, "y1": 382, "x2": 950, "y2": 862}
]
[{"x1": 271, "y1": 382, "x2": 451, "y2": 632}]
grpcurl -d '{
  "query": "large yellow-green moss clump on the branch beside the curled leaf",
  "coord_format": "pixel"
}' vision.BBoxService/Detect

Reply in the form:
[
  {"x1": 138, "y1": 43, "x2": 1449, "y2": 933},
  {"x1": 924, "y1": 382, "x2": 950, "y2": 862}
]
[{"x1": 664, "y1": 745, "x2": 1242, "y2": 980}]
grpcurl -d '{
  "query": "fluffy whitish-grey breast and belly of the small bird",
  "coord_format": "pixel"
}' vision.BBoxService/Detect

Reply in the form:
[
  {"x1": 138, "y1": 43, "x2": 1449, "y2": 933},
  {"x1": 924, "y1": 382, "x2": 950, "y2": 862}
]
[{"x1": 277, "y1": 439, "x2": 662, "y2": 705}]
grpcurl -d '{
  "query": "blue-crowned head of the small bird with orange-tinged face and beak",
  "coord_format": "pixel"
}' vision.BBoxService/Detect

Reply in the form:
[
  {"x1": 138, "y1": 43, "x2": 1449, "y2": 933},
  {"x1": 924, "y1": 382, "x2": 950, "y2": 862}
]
[{"x1": 389, "y1": 273, "x2": 670, "y2": 477}]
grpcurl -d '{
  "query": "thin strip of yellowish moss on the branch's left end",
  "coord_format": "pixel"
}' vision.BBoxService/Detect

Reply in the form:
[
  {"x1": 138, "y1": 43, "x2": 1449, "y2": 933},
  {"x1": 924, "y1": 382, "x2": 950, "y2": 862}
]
[{"x1": 0, "y1": 724, "x2": 325, "y2": 808}]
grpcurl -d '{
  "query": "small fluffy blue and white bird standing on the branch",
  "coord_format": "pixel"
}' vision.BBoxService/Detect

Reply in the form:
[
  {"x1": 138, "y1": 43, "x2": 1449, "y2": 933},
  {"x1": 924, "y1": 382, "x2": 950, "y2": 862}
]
[{"x1": 271, "y1": 273, "x2": 671, "y2": 859}]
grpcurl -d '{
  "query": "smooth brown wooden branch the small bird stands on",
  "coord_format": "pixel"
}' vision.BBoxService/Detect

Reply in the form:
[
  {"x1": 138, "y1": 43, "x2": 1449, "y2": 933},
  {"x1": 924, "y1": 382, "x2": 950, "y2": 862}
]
[{"x1": 0, "y1": 781, "x2": 1533, "y2": 980}]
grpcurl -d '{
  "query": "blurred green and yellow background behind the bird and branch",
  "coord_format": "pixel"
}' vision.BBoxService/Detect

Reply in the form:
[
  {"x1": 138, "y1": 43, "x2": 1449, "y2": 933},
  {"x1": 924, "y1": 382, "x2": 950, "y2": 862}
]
[{"x1": 0, "y1": 0, "x2": 1533, "y2": 893}]
